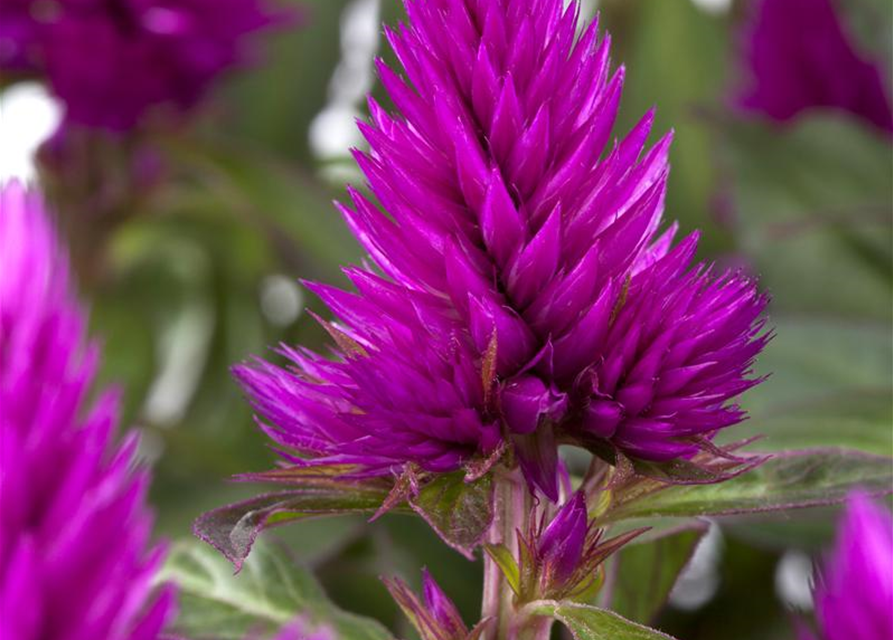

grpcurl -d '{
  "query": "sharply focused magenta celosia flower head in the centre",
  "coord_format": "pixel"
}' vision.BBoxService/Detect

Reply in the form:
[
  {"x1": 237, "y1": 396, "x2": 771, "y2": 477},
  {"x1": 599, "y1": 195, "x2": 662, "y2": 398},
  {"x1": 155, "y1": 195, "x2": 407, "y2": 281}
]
[{"x1": 237, "y1": 0, "x2": 766, "y2": 500}]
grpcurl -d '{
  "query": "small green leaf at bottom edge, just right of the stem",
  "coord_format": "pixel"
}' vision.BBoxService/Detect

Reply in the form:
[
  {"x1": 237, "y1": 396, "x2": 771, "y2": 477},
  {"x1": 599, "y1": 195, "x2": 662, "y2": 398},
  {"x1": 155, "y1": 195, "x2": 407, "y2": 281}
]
[{"x1": 530, "y1": 602, "x2": 672, "y2": 640}]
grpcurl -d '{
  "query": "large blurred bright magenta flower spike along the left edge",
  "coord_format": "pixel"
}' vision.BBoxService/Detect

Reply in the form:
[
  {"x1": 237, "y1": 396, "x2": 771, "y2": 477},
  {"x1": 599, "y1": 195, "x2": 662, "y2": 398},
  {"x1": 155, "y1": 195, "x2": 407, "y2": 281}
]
[{"x1": 0, "y1": 183, "x2": 173, "y2": 640}]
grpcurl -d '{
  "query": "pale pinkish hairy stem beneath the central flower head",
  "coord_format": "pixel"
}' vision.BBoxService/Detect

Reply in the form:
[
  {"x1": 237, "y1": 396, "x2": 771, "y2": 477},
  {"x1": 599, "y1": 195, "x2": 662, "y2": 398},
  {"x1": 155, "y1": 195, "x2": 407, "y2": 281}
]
[{"x1": 481, "y1": 469, "x2": 552, "y2": 640}]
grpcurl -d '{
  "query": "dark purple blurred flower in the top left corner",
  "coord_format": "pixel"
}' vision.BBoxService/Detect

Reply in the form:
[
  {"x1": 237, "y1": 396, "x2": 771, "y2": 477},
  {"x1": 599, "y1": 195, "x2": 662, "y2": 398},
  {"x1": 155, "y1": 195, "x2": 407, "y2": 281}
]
[{"x1": 0, "y1": 0, "x2": 283, "y2": 130}]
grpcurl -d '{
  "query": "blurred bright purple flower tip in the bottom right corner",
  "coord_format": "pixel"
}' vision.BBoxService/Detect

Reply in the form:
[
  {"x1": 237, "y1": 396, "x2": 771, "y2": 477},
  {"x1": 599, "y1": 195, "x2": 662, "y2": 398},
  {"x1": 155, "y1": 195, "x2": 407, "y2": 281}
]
[{"x1": 800, "y1": 493, "x2": 893, "y2": 640}]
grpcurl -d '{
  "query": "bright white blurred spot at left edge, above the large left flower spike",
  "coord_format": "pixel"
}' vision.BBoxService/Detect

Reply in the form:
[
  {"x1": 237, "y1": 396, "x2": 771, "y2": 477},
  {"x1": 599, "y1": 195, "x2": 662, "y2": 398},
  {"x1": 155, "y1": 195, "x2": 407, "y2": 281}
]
[{"x1": 0, "y1": 82, "x2": 62, "y2": 181}]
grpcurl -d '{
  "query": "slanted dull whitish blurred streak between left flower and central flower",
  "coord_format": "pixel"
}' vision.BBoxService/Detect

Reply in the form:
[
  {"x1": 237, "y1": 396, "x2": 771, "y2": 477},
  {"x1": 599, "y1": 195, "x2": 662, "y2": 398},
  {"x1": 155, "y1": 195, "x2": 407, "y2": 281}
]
[{"x1": 143, "y1": 302, "x2": 214, "y2": 427}]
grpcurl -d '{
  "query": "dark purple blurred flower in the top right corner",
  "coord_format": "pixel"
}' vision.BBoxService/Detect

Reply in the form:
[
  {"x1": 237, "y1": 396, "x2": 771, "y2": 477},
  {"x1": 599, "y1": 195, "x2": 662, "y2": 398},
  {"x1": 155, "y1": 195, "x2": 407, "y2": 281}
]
[{"x1": 738, "y1": 0, "x2": 893, "y2": 132}]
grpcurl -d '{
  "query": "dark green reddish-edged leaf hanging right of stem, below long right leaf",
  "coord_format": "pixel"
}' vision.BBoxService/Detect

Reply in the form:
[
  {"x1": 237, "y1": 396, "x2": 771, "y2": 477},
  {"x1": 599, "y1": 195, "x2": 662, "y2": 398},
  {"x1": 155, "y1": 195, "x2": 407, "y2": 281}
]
[{"x1": 610, "y1": 522, "x2": 708, "y2": 624}]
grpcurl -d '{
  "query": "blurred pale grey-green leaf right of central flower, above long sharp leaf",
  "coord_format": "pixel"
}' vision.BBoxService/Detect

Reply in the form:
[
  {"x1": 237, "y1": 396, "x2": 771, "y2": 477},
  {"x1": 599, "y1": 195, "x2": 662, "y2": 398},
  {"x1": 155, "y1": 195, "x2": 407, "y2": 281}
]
[{"x1": 729, "y1": 315, "x2": 893, "y2": 455}]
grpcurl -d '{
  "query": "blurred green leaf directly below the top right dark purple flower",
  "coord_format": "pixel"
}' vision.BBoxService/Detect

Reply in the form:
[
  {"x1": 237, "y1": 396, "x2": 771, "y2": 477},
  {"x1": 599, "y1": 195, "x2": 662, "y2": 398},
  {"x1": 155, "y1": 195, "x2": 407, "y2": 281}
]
[{"x1": 727, "y1": 115, "x2": 893, "y2": 321}]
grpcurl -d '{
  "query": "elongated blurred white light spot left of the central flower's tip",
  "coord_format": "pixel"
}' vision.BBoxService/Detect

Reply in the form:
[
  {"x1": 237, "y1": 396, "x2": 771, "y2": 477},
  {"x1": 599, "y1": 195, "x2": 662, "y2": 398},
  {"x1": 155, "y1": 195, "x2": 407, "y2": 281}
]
[{"x1": 309, "y1": 0, "x2": 380, "y2": 166}]
